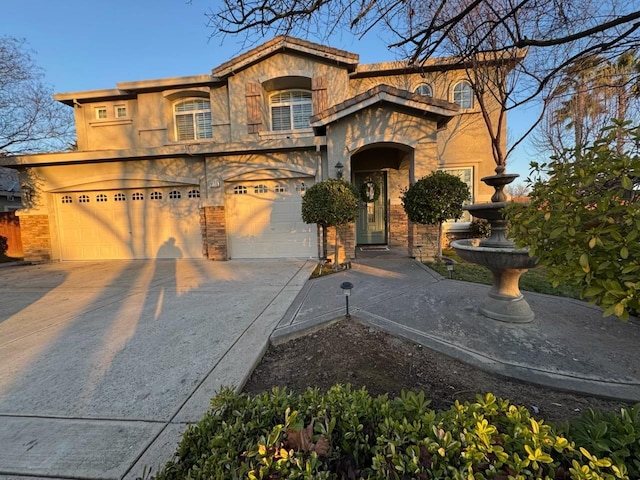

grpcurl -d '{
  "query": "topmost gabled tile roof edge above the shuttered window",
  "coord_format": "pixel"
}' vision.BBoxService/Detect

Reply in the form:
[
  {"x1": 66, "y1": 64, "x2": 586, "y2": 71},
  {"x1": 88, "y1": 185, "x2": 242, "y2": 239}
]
[{"x1": 211, "y1": 35, "x2": 360, "y2": 77}]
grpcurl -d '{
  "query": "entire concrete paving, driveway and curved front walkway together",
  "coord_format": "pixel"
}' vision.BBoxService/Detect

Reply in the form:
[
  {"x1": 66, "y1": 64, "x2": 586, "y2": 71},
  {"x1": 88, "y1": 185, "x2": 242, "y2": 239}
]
[{"x1": 0, "y1": 252, "x2": 640, "y2": 480}]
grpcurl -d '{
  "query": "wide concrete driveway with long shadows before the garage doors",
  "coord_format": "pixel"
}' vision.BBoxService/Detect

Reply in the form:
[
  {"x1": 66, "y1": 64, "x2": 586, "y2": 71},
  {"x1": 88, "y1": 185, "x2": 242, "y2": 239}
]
[{"x1": 0, "y1": 260, "x2": 314, "y2": 479}]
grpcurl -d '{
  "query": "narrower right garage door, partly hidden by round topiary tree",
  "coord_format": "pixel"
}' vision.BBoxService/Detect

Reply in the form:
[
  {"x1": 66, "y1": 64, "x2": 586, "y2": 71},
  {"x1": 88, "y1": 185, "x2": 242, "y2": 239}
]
[{"x1": 226, "y1": 178, "x2": 318, "y2": 258}]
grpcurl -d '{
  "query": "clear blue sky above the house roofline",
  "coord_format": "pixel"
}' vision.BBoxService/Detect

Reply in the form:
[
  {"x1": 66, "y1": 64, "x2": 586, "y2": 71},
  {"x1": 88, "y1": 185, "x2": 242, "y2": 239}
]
[{"x1": 0, "y1": 0, "x2": 532, "y2": 180}]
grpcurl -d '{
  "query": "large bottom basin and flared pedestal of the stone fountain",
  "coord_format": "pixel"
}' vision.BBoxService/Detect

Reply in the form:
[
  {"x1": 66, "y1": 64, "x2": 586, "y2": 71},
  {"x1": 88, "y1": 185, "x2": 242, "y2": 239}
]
[{"x1": 451, "y1": 239, "x2": 538, "y2": 323}]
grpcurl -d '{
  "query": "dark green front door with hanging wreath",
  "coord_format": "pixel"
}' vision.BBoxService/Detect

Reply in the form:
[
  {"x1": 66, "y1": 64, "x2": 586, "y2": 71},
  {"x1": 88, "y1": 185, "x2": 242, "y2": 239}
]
[{"x1": 355, "y1": 172, "x2": 387, "y2": 245}]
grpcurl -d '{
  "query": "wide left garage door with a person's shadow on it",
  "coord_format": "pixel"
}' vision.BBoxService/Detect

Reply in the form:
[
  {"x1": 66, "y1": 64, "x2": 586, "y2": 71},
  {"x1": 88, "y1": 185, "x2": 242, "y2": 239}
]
[{"x1": 56, "y1": 186, "x2": 202, "y2": 260}]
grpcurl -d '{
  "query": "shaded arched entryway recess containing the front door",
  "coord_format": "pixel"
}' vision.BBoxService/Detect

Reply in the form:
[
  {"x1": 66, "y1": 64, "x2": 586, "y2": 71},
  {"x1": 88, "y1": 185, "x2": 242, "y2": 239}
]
[{"x1": 351, "y1": 143, "x2": 413, "y2": 247}]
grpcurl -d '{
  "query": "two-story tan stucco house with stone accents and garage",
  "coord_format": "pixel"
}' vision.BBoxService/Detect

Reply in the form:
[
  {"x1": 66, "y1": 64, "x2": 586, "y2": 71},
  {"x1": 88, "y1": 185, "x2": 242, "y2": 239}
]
[{"x1": 4, "y1": 37, "x2": 502, "y2": 260}]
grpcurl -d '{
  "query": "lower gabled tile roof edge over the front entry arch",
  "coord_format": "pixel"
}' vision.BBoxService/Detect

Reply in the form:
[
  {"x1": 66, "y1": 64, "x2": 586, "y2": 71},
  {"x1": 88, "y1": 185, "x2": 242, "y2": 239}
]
[{"x1": 309, "y1": 84, "x2": 459, "y2": 128}]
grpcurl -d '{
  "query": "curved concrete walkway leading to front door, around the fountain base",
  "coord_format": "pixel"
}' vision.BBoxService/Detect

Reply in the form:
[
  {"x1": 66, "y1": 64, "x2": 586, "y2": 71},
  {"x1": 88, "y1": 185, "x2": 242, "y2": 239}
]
[{"x1": 272, "y1": 253, "x2": 640, "y2": 402}]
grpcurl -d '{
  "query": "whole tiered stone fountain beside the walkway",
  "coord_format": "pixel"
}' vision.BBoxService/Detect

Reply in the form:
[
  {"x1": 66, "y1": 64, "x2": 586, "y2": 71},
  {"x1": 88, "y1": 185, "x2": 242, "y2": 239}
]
[{"x1": 451, "y1": 166, "x2": 538, "y2": 323}]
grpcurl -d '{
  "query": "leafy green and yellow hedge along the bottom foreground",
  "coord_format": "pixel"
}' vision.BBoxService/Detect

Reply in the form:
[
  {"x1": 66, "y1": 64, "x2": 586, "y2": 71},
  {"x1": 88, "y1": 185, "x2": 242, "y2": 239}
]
[{"x1": 151, "y1": 385, "x2": 640, "y2": 480}]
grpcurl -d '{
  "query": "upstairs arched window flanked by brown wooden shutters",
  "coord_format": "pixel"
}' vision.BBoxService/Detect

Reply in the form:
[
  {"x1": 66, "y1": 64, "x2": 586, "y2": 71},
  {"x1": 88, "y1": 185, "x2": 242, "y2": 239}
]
[{"x1": 269, "y1": 90, "x2": 313, "y2": 131}]
